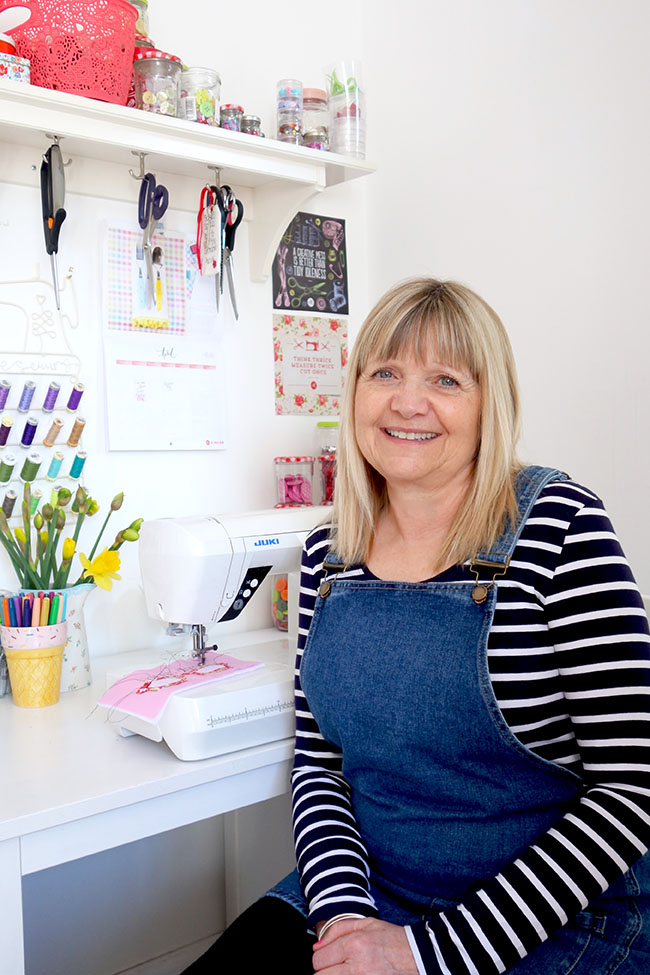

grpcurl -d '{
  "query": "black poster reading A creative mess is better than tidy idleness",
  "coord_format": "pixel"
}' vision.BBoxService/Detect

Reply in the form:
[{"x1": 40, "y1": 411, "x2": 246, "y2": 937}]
[{"x1": 273, "y1": 213, "x2": 349, "y2": 315}]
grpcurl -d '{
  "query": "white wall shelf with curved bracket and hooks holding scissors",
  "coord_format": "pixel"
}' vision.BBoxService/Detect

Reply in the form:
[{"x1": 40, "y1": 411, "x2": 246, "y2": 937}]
[{"x1": 0, "y1": 81, "x2": 375, "y2": 281}]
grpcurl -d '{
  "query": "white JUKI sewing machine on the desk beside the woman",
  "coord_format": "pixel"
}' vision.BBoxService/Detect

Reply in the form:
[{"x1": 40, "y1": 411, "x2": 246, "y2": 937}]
[{"x1": 109, "y1": 507, "x2": 328, "y2": 760}]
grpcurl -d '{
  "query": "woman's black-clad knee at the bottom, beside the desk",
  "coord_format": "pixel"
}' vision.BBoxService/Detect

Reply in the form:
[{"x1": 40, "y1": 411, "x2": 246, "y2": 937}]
[{"x1": 183, "y1": 897, "x2": 315, "y2": 975}]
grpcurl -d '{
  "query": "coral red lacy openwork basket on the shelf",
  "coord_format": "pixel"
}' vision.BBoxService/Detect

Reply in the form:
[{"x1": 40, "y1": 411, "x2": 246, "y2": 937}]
[{"x1": 0, "y1": 0, "x2": 138, "y2": 105}]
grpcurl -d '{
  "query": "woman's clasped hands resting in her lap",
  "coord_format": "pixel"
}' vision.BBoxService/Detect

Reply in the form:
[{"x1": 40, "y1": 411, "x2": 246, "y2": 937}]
[{"x1": 314, "y1": 918, "x2": 418, "y2": 975}]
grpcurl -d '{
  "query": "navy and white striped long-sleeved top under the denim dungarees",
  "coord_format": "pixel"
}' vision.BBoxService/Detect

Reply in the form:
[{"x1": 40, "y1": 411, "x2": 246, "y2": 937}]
[{"x1": 292, "y1": 481, "x2": 650, "y2": 975}]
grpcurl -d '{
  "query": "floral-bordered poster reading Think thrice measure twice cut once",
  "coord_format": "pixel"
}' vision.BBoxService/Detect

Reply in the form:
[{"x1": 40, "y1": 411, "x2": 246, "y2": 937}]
[{"x1": 273, "y1": 315, "x2": 348, "y2": 416}]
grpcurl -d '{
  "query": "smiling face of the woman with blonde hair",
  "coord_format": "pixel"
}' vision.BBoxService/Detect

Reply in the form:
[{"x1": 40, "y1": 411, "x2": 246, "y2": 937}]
[{"x1": 354, "y1": 348, "x2": 481, "y2": 490}]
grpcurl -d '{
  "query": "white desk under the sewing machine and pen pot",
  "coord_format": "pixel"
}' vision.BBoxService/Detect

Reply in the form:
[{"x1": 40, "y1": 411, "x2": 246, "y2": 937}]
[{"x1": 0, "y1": 657, "x2": 293, "y2": 975}]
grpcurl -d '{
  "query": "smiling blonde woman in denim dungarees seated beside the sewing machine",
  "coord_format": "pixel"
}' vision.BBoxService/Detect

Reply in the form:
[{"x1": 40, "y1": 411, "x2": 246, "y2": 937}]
[{"x1": 182, "y1": 279, "x2": 650, "y2": 975}]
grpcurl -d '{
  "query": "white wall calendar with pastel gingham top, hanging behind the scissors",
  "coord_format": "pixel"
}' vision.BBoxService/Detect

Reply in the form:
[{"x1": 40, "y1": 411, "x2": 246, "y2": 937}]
[{"x1": 104, "y1": 226, "x2": 226, "y2": 450}]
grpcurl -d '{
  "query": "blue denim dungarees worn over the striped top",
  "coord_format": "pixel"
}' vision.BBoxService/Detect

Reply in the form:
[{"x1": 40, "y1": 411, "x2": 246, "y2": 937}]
[{"x1": 270, "y1": 467, "x2": 650, "y2": 975}]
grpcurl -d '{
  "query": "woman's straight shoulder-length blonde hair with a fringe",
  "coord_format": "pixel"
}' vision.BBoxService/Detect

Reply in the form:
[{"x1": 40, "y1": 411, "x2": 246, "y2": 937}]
[{"x1": 332, "y1": 278, "x2": 521, "y2": 566}]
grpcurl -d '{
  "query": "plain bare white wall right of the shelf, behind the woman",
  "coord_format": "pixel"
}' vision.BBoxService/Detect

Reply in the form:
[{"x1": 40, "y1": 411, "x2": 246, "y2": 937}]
[{"x1": 366, "y1": 0, "x2": 650, "y2": 593}]
